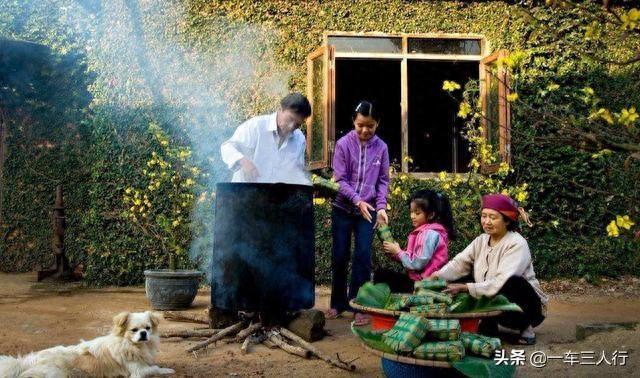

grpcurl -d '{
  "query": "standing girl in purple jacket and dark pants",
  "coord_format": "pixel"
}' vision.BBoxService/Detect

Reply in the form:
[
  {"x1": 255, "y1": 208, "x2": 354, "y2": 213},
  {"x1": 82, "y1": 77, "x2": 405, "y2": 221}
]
[{"x1": 326, "y1": 101, "x2": 389, "y2": 324}]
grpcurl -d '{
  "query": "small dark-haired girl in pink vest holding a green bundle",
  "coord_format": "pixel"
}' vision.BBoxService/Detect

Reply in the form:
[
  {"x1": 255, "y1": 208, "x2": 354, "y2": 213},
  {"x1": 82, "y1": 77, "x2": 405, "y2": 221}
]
[{"x1": 374, "y1": 189, "x2": 456, "y2": 292}]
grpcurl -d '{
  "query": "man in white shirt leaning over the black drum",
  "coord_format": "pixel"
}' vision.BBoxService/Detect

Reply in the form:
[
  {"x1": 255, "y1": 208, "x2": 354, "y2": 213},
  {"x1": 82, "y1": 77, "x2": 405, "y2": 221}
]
[{"x1": 220, "y1": 93, "x2": 311, "y2": 185}]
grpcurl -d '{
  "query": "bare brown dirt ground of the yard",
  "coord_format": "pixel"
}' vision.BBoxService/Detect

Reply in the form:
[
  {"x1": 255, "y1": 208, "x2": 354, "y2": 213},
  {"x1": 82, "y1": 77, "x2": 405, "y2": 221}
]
[{"x1": 0, "y1": 273, "x2": 640, "y2": 378}]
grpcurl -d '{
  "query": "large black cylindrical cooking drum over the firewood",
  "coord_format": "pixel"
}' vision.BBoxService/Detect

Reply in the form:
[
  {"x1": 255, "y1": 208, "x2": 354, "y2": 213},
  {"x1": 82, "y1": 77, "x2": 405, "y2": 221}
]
[{"x1": 211, "y1": 183, "x2": 315, "y2": 315}]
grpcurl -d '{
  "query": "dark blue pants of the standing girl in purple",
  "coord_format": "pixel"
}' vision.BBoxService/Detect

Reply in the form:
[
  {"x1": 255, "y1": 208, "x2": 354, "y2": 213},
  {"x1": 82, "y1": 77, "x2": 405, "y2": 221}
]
[{"x1": 331, "y1": 206, "x2": 376, "y2": 312}]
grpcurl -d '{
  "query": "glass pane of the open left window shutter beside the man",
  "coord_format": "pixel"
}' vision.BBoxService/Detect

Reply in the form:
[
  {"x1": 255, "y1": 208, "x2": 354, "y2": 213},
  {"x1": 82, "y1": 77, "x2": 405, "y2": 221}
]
[{"x1": 310, "y1": 55, "x2": 325, "y2": 162}]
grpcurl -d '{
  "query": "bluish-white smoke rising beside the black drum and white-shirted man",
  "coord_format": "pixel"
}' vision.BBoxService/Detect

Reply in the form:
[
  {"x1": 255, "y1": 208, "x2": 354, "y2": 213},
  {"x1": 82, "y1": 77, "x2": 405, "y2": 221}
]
[{"x1": 0, "y1": 0, "x2": 290, "y2": 271}]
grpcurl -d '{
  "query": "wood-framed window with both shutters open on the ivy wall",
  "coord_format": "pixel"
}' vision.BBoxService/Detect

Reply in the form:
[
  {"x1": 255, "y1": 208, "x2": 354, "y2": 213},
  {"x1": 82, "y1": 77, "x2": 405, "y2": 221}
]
[{"x1": 307, "y1": 32, "x2": 509, "y2": 173}]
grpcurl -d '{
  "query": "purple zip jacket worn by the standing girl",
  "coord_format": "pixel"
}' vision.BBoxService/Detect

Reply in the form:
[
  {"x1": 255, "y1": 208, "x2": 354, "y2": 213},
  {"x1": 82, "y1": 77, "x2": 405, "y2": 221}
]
[{"x1": 333, "y1": 130, "x2": 389, "y2": 212}]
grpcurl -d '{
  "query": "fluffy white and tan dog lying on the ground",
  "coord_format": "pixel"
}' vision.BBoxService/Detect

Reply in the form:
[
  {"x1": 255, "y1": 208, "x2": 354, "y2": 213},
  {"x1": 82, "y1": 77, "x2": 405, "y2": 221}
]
[{"x1": 0, "y1": 311, "x2": 175, "y2": 378}]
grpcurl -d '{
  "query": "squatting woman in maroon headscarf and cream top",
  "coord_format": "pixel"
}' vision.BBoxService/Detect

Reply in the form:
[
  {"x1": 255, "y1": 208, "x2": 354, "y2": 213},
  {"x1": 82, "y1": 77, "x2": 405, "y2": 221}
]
[{"x1": 432, "y1": 194, "x2": 548, "y2": 345}]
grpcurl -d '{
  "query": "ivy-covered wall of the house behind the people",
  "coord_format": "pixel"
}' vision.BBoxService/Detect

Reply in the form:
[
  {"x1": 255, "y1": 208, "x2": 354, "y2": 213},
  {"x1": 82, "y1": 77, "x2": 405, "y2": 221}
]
[{"x1": 0, "y1": 0, "x2": 640, "y2": 285}]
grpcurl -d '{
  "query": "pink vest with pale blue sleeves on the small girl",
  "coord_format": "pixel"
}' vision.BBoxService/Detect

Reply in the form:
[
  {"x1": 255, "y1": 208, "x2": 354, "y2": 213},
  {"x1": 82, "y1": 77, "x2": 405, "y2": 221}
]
[{"x1": 395, "y1": 223, "x2": 449, "y2": 281}]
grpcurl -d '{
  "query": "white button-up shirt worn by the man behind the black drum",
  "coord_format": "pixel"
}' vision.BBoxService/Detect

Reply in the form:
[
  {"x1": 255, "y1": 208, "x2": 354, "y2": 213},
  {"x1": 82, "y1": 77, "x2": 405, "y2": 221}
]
[{"x1": 220, "y1": 113, "x2": 311, "y2": 185}]
